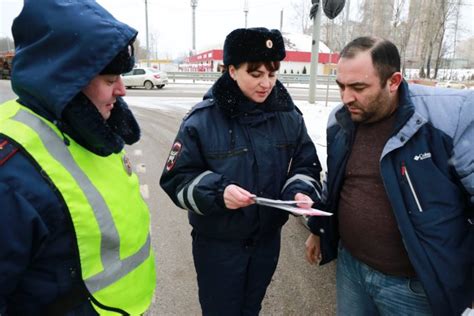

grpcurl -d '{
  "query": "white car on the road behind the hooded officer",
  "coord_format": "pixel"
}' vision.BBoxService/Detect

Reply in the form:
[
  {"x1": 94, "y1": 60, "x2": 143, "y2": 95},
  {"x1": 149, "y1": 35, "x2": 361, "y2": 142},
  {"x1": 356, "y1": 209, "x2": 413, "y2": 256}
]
[{"x1": 122, "y1": 68, "x2": 168, "y2": 90}]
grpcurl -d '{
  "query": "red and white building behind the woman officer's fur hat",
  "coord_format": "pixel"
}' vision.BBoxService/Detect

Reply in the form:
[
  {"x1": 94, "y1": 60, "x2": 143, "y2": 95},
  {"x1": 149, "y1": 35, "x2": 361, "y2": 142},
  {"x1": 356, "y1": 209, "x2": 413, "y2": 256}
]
[{"x1": 179, "y1": 33, "x2": 339, "y2": 74}]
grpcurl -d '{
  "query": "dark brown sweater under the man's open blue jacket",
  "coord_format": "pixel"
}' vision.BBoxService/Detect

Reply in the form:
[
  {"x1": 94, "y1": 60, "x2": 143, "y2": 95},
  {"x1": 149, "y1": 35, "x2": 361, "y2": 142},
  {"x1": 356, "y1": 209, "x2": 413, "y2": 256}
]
[{"x1": 338, "y1": 115, "x2": 415, "y2": 277}]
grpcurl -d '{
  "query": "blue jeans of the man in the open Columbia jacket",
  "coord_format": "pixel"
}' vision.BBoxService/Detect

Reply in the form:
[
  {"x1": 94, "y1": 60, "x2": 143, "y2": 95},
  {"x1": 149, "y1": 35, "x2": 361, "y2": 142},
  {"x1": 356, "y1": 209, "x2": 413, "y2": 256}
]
[{"x1": 336, "y1": 246, "x2": 432, "y2": 316}]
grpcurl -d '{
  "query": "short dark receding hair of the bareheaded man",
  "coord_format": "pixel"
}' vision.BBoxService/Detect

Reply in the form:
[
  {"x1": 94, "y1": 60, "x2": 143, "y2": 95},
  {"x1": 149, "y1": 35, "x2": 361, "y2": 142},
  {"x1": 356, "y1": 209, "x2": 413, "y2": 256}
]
[{"x1": 340, "y1": 36, "x2": 400, "y2": 86}]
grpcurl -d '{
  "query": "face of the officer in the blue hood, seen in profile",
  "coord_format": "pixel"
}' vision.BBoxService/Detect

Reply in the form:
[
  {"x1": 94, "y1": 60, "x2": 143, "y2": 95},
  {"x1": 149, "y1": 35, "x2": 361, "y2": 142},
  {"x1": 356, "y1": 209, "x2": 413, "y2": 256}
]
[{"x1": 82, "y1": 75, "x2": 125, "y2": 120}]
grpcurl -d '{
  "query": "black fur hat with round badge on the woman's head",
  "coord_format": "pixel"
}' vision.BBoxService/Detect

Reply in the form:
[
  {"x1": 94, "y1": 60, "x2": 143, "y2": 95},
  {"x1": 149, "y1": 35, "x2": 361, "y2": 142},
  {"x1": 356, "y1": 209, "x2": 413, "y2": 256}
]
[{"x1": 224, "y1": 27, "x2": 286, "y2": 66}]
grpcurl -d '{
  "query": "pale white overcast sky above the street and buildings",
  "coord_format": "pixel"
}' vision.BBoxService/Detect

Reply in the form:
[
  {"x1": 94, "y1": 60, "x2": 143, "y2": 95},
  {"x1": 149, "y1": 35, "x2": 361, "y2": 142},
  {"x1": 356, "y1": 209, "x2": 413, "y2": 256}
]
[{"x1": 0, "y1": 0, "x2": 474, "y2": 58}]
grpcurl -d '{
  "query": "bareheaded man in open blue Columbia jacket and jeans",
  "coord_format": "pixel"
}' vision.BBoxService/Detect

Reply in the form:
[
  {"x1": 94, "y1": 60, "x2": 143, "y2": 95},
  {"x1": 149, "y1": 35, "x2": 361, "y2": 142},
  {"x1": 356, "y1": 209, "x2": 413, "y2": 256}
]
[{"x1": 306, "y1": 37, "x2": 474, "y2": 315}]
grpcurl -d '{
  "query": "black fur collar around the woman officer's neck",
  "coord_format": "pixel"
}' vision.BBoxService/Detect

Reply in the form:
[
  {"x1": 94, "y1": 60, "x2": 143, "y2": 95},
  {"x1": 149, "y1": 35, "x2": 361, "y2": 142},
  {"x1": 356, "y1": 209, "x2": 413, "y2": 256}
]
[{"x1": 211, "y1": 72, "x2": 295, "y2": 116}]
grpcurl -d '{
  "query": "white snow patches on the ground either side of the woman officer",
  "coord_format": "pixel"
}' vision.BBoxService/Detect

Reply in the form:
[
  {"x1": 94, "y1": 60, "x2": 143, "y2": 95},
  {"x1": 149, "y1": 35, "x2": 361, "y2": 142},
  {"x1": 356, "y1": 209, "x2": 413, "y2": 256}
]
[{"x1": 125, "y1": 96, "x2": 339, "y2": 170}]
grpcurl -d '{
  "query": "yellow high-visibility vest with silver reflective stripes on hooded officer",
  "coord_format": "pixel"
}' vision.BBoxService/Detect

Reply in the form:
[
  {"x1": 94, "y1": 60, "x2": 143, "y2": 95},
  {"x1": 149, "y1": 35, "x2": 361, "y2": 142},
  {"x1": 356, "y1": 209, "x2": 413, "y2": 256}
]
[{"x1": 0, "y1": 100, "x2": 156, "y2": 315}]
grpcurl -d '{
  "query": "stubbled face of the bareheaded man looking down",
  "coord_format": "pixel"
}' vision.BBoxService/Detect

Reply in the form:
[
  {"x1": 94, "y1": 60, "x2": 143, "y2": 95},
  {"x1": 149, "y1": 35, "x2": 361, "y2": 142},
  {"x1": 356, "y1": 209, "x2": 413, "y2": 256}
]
[{"x1": 336, "y1": 51, "x2": 398, "y2": 123}]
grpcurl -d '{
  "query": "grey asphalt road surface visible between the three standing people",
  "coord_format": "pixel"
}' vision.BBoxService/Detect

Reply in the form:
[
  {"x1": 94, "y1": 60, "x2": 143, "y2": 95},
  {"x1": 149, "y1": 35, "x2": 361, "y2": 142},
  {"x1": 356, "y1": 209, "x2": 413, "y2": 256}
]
[{"x1": 0, "y1": 80, "x2": 335, "y2": 315}]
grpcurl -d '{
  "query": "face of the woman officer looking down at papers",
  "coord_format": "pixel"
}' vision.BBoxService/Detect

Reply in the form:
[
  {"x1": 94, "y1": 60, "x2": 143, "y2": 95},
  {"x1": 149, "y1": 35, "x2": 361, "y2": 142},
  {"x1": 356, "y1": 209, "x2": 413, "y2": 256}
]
[{"x1": 229, "y1": 63, "x2": 277, "y2": 103}]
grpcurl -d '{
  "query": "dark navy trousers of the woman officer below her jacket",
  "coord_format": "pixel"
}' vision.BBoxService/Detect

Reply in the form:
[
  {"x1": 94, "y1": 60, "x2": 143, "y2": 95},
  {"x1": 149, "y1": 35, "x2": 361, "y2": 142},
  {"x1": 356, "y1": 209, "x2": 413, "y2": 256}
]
[{"x1": 192, "y1": 230, "x2": 281, "y2": 316}]
